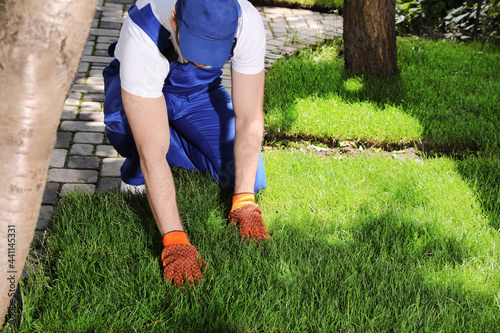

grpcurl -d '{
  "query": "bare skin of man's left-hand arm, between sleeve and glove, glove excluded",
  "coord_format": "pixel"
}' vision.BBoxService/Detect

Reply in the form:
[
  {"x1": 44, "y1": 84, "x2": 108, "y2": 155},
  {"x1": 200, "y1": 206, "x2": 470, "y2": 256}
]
[{"x1": 122, "y1": 89, "x2": 183, "y2": 235}]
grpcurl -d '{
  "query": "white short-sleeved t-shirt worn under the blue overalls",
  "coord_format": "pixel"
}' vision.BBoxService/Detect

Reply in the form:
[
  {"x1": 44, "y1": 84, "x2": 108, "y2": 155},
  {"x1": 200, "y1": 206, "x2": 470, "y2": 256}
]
[{"x1": 115, "y1": 0, "x2": 266, "y2": 98}]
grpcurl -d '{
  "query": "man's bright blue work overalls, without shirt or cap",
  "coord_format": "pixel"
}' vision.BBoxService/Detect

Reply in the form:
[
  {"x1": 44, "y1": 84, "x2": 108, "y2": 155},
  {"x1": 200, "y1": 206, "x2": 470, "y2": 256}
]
[{"x1": 103, "y1": 5, "x2": 266, "y2": 193}]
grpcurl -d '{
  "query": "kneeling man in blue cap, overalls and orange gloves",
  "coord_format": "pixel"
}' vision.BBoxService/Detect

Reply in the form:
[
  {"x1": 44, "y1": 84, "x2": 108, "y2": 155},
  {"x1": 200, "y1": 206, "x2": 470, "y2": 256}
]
[{"x1": 99, "y1": 0, "x2": 267, "y2": 285}]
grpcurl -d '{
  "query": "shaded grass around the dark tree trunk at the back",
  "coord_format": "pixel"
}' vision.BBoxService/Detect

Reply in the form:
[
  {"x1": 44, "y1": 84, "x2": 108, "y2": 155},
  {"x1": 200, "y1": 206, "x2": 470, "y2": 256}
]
[{"x1": 265, "y1": 39, "x2": 500, "y2": 152}]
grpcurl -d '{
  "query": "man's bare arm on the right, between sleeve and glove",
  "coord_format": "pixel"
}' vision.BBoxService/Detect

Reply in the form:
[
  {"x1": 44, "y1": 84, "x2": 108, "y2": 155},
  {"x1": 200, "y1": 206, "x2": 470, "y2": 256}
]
[{"x1": 231, "y1": 70, "x2": 265, "y2": 193}]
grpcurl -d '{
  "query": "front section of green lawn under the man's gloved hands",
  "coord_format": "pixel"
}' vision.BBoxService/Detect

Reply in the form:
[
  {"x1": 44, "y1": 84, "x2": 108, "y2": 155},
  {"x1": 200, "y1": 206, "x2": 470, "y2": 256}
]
[{"x1": 9, "y1": 151, "x2": 500, "y2": 332}]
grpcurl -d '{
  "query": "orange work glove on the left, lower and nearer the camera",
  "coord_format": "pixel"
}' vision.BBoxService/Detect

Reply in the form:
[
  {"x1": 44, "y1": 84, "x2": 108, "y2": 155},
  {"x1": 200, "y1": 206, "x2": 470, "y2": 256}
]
[{"x1": 161, "y1": 231, "x2": 205, "y2": 286}]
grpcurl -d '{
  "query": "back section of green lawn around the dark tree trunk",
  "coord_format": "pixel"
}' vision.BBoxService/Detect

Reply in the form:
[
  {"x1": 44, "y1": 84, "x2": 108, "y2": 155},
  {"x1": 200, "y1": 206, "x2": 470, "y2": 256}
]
[{"x1": 265, "y1": 38, "x2": 500, "y2": 152}]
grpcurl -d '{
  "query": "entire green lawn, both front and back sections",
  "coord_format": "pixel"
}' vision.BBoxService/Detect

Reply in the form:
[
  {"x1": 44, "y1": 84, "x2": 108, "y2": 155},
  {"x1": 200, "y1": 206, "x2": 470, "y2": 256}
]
[{"x1": 6, "y1": 39, "x2": 500, "y2": 332}]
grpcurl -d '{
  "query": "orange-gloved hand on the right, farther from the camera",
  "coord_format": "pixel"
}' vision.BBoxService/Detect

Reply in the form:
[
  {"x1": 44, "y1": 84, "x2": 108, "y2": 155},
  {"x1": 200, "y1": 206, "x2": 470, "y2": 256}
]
[{"x1": 229, "y1": 193, "x2": 269, "y2": 241}]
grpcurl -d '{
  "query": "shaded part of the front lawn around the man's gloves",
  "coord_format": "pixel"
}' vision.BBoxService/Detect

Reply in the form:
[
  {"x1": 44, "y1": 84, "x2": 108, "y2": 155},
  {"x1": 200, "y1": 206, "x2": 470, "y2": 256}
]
[{"x1": 12, "y1": 183, "x2": 499, "y2": 332}]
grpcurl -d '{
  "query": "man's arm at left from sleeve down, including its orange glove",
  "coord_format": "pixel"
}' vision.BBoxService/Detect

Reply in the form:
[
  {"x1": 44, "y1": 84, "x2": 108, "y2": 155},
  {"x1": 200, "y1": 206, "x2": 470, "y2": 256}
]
[{"x1": 122, "y1": 89, "x2": 204, "y2": 286}]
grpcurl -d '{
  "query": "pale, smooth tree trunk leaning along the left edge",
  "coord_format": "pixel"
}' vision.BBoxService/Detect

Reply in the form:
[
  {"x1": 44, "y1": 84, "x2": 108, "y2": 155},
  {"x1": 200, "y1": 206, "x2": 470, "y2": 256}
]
[{"x1": 0, "y1": 0, "x2": 97, "y2": 325}]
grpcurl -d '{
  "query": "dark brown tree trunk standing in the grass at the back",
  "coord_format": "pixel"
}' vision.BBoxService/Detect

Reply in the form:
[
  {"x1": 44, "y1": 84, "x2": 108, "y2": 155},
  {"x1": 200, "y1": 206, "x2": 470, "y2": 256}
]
[{"x1": 344, "y1": 0, "x2": 398, "y2": 75}]
